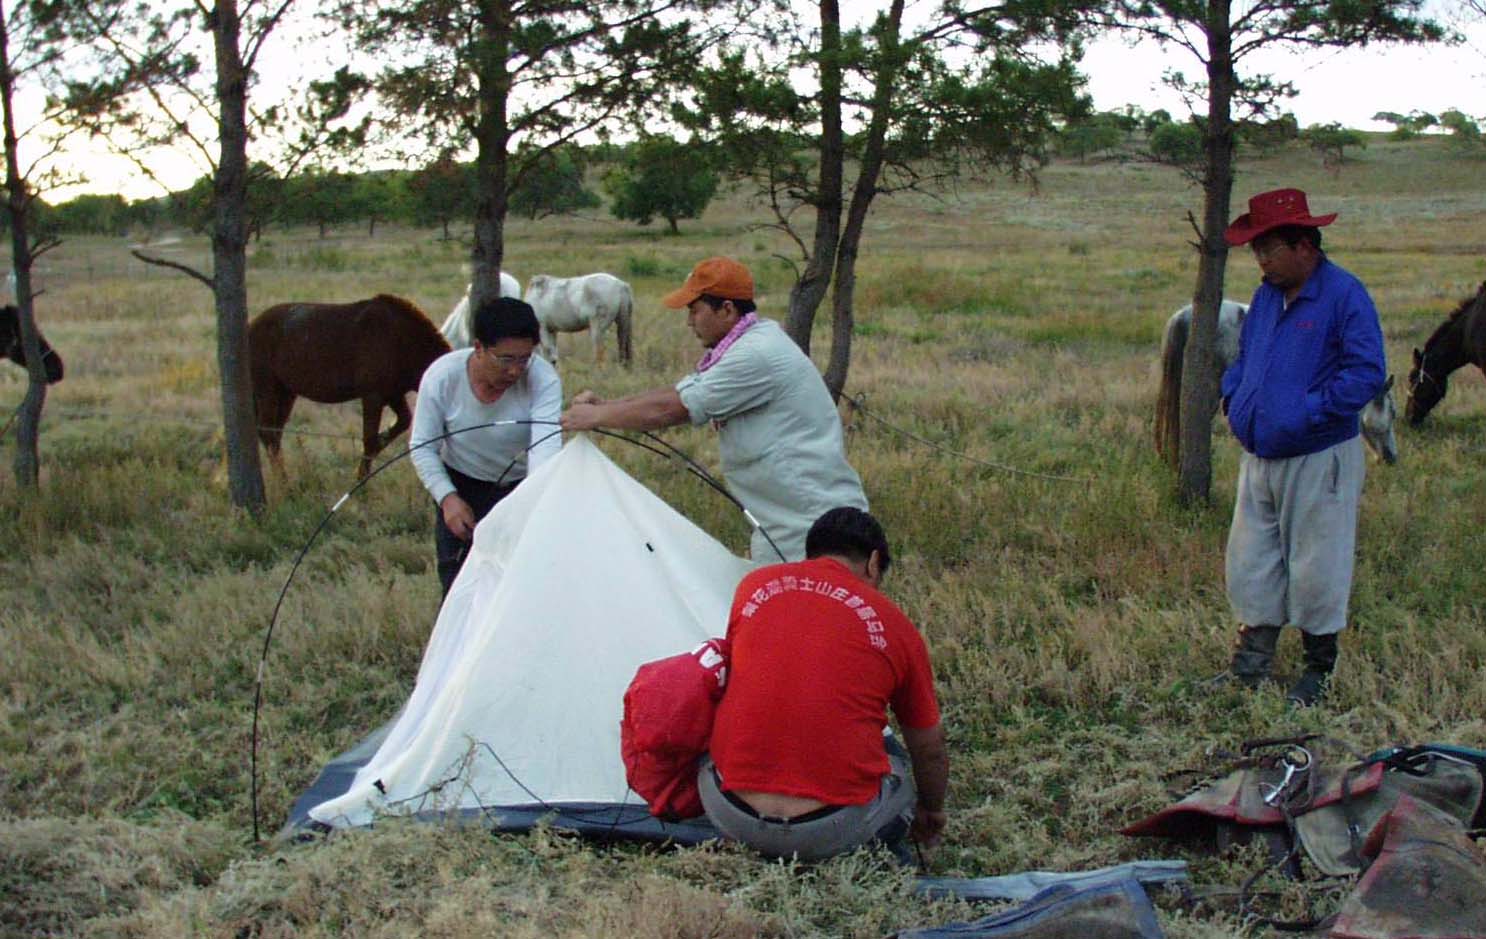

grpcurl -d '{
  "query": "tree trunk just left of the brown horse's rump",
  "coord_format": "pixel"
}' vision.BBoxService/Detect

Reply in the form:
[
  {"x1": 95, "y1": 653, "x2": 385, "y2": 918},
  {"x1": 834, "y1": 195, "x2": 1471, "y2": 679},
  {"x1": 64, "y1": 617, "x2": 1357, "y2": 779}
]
[{"x1": 211, "y1": 0, "x2": 265, "y2": 514}]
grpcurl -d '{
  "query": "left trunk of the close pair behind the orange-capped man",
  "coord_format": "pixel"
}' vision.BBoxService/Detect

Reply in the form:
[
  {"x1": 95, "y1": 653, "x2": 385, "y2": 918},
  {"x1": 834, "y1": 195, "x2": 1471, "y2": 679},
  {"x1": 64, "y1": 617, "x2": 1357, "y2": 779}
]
[{"x1": 785, "y1": 0, "x2": 850, "y2": 355}]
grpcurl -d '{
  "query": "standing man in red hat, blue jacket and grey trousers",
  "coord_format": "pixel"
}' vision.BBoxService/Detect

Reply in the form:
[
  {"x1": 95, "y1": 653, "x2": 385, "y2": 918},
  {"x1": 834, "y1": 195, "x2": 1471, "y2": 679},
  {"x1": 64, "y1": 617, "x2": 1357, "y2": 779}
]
[{"x1": 1221, "y1": 189, "x2": 1388, "y2": 707}]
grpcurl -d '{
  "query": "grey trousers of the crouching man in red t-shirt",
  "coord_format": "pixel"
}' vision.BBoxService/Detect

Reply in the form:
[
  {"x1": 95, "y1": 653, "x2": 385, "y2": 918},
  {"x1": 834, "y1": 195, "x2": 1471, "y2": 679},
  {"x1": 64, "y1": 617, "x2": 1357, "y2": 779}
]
[{"x1": 697, "y1": 750, "x2": 918, "y2": 860}]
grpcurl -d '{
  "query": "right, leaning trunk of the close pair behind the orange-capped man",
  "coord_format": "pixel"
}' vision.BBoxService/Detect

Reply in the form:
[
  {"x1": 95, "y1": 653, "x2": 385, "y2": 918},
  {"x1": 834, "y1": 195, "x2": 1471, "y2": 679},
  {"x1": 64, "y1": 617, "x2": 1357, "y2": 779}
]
[{"x1": 825, "y1": 0, "x2": 903, "y2": 401}]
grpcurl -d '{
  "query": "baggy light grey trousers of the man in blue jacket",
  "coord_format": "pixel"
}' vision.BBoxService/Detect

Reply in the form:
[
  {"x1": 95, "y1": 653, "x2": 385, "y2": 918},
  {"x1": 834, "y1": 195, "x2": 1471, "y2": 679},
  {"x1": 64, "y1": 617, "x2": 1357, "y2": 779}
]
[{"x1": 1224, "y1": 437, "x2": 1364, "y2": 636}]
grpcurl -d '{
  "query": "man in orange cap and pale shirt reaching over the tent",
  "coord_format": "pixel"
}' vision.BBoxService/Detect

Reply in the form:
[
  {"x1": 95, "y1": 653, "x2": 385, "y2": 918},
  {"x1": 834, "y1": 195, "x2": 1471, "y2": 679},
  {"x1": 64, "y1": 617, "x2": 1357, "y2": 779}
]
[{"x1": 562, "y1": 257, "x2": 868, "y2": 563}]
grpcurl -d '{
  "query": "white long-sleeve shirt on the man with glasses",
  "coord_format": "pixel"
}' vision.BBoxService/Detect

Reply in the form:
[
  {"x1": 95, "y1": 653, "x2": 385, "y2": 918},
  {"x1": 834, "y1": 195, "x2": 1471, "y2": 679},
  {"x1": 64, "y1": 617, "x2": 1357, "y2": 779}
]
[{"x1": 409, "y1": 349, "x2": 562, "y2": 504}]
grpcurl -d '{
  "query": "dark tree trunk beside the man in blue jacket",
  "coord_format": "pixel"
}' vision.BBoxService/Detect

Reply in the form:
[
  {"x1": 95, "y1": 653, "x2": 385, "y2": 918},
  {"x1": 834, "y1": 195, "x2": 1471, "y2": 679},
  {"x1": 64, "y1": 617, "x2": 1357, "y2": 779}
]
[{"x1": 1177, "y1": 0, "x2": 1236, "y2": 505}]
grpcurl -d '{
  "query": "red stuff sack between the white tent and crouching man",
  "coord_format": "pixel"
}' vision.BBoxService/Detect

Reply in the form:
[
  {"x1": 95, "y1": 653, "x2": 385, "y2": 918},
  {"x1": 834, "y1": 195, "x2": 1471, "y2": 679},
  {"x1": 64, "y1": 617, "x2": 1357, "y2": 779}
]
[{"x1": 620, "y1": 639, "x2": 728, "y2": 820}]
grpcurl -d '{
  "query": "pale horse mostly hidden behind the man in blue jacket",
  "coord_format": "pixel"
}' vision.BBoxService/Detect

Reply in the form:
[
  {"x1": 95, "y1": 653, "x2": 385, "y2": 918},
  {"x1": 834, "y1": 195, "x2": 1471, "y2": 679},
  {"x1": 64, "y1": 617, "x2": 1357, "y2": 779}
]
[{"x1": 1156, "y1": 300, "x2": 1398, "y2": 467}]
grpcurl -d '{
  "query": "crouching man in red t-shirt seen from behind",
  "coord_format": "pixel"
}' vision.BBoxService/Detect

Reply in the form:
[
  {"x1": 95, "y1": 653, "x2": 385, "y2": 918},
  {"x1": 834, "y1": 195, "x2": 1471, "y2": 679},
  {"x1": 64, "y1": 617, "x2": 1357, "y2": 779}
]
[{"x1": 697, "y1": 507, "x2": 950, "y2": 860}]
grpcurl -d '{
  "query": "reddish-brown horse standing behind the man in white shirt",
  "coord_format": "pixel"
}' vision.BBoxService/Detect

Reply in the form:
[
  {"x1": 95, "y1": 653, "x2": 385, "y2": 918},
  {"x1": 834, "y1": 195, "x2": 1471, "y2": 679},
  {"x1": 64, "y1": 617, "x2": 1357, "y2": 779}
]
[{"x1": 248, "y1": 294, "x2": 449, "y2": 477}]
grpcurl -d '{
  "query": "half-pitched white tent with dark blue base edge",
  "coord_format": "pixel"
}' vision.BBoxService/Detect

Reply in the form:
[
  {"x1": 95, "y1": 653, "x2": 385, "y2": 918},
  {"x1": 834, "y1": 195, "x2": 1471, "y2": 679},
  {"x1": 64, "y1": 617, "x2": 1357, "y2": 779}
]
[{"x1": 291, "y1": 435, "x2": 750, "y2": 841}]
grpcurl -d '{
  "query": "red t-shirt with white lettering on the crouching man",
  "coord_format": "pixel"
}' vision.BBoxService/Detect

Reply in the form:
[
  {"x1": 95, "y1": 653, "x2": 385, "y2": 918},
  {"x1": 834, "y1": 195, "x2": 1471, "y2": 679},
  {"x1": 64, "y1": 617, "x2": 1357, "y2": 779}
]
[{"x1": 712, "y1": 559, "x2": 939, "y2": 805}]
